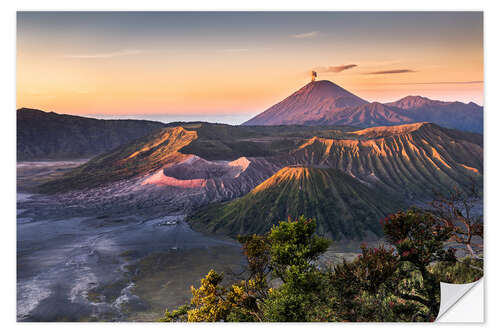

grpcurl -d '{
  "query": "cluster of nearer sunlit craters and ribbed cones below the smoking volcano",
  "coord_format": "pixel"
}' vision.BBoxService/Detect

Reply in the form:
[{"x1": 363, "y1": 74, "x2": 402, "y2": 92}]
[{"x1": 40, "y1": 123, "x2": 483, "y2": 239}]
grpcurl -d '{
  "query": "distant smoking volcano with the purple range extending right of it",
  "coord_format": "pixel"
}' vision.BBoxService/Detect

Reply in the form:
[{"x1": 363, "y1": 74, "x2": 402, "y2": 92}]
[{"x1": 242, "y1": 80, "x2": 483, "y2": 133}]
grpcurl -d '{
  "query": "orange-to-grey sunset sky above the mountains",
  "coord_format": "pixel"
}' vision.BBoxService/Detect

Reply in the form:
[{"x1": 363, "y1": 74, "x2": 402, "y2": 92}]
[{"x1": 17, "y1": 12, "x2": 483, "y2": 124}]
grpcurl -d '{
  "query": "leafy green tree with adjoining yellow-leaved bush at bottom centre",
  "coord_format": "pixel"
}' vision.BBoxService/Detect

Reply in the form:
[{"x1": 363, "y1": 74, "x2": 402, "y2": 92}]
[{"x1": 161, "y1": 217, "x2": 329, "y2": 321}]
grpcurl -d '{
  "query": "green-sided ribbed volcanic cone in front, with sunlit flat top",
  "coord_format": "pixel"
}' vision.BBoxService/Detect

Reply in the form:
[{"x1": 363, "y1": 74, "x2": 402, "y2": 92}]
[{"x1": 188, "y1": 166, "x2": 403, "y2": 239}]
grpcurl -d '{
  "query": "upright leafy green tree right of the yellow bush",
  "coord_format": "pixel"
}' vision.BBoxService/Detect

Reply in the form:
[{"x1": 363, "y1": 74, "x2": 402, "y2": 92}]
[{"x1": 263, "y1": 216, "x2": 330, "y2": 321}]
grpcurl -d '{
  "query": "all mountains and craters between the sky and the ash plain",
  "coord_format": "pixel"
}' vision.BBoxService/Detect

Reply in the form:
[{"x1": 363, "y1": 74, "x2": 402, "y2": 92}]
[{"x1": 17, "y1": 81, "x2": 483, "y2": 239}]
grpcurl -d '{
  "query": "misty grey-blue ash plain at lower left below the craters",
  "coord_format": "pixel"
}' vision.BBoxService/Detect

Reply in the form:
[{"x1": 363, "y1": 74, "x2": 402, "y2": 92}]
[{"x1": 17, "y1": 160, "x2": 368, "y2": 321}]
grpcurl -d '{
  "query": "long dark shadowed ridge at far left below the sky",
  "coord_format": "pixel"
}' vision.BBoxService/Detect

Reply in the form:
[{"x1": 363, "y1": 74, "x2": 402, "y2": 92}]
[{"x1": 17, "y1": 108, "x2": 165, "y2": 161}]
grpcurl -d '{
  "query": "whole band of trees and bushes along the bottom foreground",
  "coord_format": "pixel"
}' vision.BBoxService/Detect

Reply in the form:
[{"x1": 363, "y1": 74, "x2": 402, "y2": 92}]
[{"x1": 160, "y1": 193, "x2": 483, "y2": 322}]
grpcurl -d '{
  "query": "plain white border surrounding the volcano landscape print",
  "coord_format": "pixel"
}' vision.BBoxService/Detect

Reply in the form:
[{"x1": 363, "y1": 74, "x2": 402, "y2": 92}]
[{"x1": 0, "y1": 0, "x2": 500, "y2": 332}]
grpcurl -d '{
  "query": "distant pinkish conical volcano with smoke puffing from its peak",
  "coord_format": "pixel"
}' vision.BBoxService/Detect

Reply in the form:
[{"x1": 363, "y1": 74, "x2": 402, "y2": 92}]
[{"x1": 243, "y1": 80, "x2": 368, "y2": 125}]
